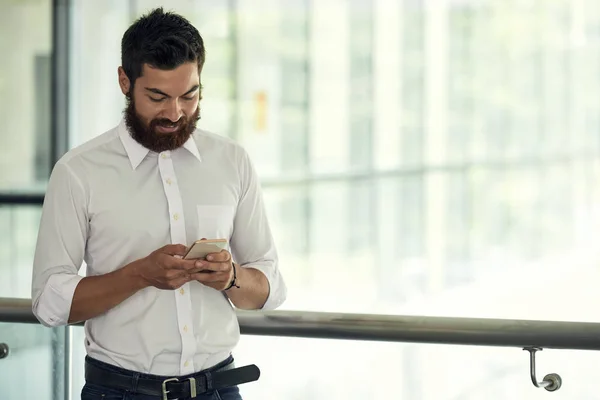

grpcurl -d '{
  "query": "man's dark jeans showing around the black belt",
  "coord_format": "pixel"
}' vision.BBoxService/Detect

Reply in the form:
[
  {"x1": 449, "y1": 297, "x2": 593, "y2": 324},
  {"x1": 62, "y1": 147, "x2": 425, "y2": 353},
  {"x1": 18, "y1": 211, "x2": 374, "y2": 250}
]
[{"x1": 81, "y1": 357, "x2": 242, "y2": 400}]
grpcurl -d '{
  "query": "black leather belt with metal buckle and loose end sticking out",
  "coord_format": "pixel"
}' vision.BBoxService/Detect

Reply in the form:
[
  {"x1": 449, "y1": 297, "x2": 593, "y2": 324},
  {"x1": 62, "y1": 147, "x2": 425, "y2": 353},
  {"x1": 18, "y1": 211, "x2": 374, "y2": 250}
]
[{"x1": 85, "y1": 362, "x2": 260, "y2": 400}]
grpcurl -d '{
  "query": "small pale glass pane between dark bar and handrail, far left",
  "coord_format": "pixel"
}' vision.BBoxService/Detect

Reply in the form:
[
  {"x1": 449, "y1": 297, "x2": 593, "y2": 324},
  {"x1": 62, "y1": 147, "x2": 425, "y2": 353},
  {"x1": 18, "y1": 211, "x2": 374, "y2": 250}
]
[{"x1": 0, "y1": 206, "x2": 42, "y2": 298}]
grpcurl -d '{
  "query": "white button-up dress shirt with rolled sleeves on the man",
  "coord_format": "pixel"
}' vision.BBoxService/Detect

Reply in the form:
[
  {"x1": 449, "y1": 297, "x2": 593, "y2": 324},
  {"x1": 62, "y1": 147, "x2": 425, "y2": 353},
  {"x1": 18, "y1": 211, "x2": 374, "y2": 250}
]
[{"x1": 32, "y1": 122, "x2": 286, "y2": 376}]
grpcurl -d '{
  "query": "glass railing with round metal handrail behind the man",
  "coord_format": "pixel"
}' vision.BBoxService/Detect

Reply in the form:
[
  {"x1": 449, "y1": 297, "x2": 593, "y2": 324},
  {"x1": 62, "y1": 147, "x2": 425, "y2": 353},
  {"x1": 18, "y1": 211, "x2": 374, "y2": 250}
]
[{"x1": 0, "y1": 298, "x2": 600, "y2": 400}]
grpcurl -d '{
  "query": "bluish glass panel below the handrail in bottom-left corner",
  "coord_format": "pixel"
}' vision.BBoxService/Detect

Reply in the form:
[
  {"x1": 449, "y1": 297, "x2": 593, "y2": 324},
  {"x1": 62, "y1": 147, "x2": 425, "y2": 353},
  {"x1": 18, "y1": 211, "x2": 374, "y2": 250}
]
[{"x1": 0, "y1": 323, "x2": 66, "y2": 400}]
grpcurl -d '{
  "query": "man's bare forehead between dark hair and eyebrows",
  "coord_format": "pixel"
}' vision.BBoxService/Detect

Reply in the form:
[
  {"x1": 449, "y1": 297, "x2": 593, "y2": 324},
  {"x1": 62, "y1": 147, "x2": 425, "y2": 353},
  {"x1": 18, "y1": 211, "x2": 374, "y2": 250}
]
[{"x1": 138, "y1": 62, "x2": 200, "y2": 93}]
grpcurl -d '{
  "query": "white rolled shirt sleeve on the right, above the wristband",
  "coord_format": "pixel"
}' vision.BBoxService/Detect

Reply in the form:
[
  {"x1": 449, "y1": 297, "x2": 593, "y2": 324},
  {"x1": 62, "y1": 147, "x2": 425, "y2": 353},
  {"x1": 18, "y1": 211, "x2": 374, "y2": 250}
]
[{"x1": 231, "y1": 151, "x2": 287, "y2": 310}]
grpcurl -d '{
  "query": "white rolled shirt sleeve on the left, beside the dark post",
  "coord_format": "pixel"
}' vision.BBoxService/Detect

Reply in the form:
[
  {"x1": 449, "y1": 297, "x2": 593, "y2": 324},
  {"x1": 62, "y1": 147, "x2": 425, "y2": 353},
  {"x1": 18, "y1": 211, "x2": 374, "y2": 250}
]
[{"x1": 31, "y1": 161, "x2": 88, "y2": 326}]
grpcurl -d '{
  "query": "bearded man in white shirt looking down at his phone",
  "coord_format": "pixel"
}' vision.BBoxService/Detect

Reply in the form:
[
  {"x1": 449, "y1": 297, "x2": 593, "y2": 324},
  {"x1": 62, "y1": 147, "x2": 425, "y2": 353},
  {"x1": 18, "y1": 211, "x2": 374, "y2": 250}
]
[{"x1": 32, "y1": 9, "x2": 286, "y2": 400}]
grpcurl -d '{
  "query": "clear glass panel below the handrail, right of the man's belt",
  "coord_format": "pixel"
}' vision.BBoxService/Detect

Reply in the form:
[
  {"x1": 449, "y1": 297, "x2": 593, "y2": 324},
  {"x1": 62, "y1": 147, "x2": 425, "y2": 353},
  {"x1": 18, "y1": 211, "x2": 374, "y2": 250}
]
[{"x1": 234, "y1": 336, "x2": 600, "y2": 400}]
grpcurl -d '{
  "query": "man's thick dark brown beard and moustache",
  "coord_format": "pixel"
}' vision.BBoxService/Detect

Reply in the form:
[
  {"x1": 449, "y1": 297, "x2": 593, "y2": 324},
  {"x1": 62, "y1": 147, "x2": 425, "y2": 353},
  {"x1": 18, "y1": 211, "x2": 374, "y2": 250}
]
[{"x1": 123, "y1": 96, "x2": 200, "y2": 153}]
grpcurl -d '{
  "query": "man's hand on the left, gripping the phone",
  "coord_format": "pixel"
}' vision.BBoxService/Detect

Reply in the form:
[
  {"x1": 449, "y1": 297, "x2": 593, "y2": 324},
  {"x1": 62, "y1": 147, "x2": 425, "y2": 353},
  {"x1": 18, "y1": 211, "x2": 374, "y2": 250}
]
[{"x1": 135, "y1": 244, "x2": 196, "y2": 290}]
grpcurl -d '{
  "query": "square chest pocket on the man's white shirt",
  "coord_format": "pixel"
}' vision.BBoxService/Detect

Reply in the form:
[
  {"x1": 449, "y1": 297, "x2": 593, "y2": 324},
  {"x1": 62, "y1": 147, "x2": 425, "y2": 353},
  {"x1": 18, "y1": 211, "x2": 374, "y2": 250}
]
[{"x1": 196, "y1": 205, "x2": 235, "y2": 240}]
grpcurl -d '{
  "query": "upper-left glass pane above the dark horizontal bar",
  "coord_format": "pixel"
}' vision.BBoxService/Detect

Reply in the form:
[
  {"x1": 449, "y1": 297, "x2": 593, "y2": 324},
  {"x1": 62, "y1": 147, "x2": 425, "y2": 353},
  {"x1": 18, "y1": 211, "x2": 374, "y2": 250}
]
[{"x1": 0, "y1": 0, "x2": 52, "y2": 191}]
